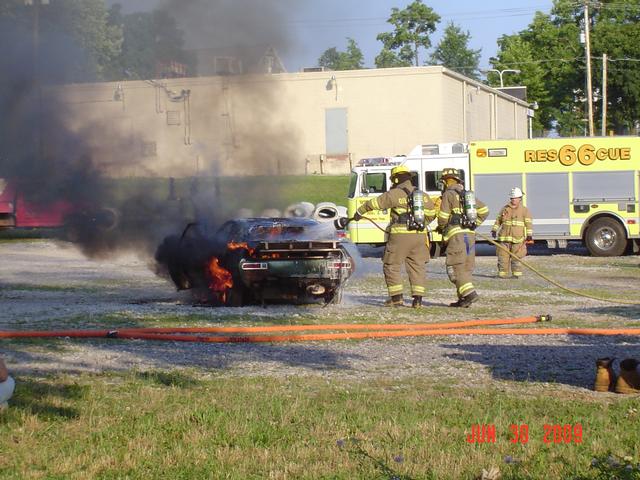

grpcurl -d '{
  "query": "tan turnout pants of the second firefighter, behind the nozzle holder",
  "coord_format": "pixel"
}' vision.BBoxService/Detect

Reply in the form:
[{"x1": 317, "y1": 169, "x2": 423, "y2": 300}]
[{"x1": 446, "y1": 233, "x2": 476, "y2": 298}]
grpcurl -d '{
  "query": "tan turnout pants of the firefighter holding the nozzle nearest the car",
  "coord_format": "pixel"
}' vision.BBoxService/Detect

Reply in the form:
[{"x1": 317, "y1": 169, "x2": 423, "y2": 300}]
[{"x1": 382, "y1": 233, "x2": 429, "y2": 297}]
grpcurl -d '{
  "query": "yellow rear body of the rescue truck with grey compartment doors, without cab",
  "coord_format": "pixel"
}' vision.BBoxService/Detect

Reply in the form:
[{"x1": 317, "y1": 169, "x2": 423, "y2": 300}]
[{"x1": 469, "y1": 137, "x2": 640, "y2": 256}]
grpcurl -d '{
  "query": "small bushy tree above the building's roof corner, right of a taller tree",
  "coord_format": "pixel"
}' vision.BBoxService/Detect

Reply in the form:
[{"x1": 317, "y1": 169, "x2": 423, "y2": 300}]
[{"x1": 431, "y1": 22, "x2": 480, "y2": 79}]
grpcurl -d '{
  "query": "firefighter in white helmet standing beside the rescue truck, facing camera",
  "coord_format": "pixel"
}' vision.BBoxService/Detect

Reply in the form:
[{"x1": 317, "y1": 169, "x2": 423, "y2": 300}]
[{"x1": 491, "y1": 187, "x2": 533, "y2": 278}]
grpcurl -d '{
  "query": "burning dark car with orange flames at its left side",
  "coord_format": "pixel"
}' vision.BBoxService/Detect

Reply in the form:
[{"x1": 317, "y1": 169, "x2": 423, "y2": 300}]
[{"x1": 156, "y1": 218, "x2": 354, "y2": 306}]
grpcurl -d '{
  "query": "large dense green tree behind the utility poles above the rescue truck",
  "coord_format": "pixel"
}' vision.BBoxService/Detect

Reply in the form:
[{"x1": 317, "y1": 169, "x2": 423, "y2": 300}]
[{"x1": 491, "y1": 0, "x2": 640, "y2": 135}]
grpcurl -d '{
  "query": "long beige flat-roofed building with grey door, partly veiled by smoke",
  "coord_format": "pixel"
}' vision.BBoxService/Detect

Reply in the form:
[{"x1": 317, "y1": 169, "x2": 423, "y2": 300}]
[{"x1": 50, "y1": 66, "x2": 528, "y2": 176}]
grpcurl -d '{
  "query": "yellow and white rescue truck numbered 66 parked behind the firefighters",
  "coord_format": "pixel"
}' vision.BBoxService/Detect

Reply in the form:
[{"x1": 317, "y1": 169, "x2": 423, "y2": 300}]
[{"x1": 348, "y1": 137, "x2": 640, "y2": 256}]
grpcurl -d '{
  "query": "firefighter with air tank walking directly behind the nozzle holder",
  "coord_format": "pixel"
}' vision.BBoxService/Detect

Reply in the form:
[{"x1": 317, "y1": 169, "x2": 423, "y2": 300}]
[{"x1": 438, "y1": 168, "x2": 489, "y2": 308}]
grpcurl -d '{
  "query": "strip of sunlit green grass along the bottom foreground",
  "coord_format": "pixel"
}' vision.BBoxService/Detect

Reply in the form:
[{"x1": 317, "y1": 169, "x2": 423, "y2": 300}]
[{"x1": 0, "y1": 371, "x2": 640, "y2": 479}]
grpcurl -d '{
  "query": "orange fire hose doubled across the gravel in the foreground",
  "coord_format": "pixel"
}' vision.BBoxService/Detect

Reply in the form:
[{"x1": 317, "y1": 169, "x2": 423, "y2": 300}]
[{"x1": 0, "y1": 315, "x2": 640, "y2": 343}]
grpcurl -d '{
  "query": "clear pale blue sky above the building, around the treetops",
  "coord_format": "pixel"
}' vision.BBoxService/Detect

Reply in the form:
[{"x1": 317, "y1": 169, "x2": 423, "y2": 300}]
[{"x1": 107, "y1": 0, "x2": 553, "y2": 72}]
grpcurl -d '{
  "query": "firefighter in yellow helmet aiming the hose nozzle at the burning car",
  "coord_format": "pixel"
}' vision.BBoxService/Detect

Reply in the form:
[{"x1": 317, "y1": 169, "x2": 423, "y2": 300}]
[{"x1": 353, "y1": 165, "x2": 435, "y2": 308}]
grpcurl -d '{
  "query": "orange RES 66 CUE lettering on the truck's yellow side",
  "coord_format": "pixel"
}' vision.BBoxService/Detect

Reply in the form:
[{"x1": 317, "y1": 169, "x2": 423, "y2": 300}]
[{"x1": 524, "y1": 143, "x2": 631, "y2": 167}]
